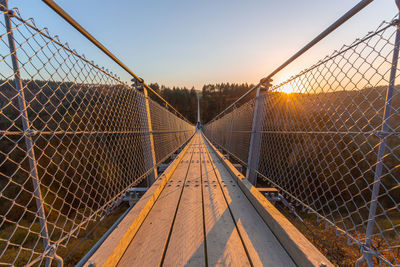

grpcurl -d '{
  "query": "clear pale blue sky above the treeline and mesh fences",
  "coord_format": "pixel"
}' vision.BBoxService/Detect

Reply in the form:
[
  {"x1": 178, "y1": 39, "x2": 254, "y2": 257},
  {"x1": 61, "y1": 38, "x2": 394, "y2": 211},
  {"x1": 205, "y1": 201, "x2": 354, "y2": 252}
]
[{"x1": 9, "y1": 0, "x2": 397, "y2": 89}]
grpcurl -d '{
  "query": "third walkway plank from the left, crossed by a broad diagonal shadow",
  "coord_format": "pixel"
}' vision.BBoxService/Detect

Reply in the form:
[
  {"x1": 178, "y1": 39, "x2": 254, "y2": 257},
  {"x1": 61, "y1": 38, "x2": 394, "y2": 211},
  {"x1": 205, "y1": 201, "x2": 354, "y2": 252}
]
[{"x1": 201, "y1": 143, "x2": 250, "y2": 266}]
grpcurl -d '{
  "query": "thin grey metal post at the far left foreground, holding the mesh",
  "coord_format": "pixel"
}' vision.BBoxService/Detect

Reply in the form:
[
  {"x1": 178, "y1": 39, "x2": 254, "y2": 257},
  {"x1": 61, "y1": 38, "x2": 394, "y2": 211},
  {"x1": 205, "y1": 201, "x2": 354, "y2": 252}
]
[{"x1": 0, "y1": 0, "x2": 60, "y2": 266}]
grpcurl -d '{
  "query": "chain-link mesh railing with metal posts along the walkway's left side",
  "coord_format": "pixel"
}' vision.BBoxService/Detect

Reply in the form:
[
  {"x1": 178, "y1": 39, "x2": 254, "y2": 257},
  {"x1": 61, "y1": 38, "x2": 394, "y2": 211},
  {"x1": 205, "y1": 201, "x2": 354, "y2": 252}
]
[{"x1": 0, "y1": 0, "x2": 194, "y2": 266}]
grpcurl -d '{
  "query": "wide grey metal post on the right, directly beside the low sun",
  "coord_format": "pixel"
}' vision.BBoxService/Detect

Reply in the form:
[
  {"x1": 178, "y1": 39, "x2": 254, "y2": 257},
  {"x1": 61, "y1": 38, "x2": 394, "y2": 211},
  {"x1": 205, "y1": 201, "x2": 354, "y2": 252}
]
[{"x1": 246, "y1": 86, "x2": 268, "y2": 185}]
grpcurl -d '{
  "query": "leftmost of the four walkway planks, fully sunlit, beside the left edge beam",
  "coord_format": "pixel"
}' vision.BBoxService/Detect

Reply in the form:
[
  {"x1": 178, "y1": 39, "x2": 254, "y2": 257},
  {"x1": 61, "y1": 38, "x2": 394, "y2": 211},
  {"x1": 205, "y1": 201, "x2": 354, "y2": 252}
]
[{"x1": 118, "y1": 141, "x2": 196, "y2": 266}]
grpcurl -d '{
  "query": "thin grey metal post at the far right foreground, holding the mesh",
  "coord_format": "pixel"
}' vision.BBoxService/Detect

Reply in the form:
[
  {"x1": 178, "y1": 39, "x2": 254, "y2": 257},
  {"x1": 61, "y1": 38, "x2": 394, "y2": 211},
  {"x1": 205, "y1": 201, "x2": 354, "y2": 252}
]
[{"x1": 356, "y1": 0, "x2": 400, "y2": 267}]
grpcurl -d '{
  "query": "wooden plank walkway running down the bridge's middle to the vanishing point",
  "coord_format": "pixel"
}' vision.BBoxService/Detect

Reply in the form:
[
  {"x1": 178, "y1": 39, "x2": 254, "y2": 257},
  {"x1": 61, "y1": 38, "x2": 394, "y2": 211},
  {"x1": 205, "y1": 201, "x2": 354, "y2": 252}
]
[{"x1": 87, "y1": 132, "x2": 328, "y2": 266}]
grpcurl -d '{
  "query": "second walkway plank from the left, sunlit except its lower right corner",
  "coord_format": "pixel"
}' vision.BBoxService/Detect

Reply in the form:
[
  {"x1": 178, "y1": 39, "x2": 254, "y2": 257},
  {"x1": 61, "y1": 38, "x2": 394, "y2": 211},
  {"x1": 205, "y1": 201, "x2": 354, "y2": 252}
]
[{"x1": 163, "y1": 139, "x2": 206, "y2": 266}]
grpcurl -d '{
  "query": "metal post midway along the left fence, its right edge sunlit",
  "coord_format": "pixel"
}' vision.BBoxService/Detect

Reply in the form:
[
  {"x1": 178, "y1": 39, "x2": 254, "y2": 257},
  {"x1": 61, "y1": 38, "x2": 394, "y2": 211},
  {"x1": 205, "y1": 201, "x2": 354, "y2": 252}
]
[{"x1": 133, "y1": 79, "x2": 158, "y2": 187}]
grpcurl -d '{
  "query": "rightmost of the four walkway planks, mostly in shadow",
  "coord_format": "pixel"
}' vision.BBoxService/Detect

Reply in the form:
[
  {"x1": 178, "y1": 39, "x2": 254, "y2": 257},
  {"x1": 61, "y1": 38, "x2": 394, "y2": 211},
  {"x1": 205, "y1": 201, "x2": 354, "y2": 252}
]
[{"x1": 203, "y1": 136, "x2": 296, "y2": 266}]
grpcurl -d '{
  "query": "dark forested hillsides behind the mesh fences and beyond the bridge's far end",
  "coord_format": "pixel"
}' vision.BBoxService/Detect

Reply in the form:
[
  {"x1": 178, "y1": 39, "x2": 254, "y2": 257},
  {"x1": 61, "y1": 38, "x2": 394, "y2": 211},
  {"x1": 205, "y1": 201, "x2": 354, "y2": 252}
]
[{"x1": 0, "y1": 80, "x2": 400, "y2": 265}]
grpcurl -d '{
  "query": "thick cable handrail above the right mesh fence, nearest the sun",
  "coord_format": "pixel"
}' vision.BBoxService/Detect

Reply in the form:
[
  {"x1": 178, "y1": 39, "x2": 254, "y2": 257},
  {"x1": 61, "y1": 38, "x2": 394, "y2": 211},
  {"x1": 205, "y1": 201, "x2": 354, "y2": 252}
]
[{"x1": 208, "y1": 0, "x2": 374, "y2": 121}]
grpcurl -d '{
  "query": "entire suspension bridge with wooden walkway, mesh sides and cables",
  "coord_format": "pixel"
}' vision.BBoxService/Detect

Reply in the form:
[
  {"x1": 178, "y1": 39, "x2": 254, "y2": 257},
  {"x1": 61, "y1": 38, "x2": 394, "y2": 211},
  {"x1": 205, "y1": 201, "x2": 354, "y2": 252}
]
[{"x1": 0, "y1": 0, "x2": 400, "y2": 267}]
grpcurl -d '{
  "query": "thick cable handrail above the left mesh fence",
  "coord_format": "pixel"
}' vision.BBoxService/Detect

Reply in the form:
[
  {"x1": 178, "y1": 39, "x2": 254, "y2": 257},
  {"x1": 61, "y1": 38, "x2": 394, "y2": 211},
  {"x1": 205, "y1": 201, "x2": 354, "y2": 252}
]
[{"x1": 42, "y1": 0, "x2": 188, "y2": 121}]
